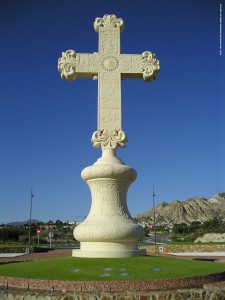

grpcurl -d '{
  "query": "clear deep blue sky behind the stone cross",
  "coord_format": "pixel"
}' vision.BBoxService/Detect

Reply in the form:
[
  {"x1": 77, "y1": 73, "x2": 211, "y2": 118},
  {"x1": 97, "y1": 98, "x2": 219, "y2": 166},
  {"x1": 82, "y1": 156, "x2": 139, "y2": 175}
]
[{"x1": 0, "y1": 0, "x2": 225, "y2": 223}]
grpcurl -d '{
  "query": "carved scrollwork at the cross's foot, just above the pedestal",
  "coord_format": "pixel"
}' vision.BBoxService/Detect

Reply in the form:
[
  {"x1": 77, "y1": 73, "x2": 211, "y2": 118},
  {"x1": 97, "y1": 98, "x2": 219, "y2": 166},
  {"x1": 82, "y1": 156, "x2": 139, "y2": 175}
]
[{"x1": 91, "y1": 129, "x2": 128, "y2": 149}]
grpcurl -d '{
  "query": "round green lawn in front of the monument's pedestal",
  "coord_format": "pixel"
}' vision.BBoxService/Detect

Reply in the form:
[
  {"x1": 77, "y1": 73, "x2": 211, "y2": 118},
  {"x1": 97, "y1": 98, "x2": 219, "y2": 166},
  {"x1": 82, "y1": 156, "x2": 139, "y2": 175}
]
[{"x1": 0, "y1": 256, "x2": 225, "y2": 281}]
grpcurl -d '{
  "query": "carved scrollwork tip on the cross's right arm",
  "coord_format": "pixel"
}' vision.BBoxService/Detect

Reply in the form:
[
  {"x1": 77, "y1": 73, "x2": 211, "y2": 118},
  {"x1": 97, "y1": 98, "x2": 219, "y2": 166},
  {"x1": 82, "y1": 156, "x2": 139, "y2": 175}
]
[{"x1": 141, "y1": 51, "x2": 160, "y2": 81}]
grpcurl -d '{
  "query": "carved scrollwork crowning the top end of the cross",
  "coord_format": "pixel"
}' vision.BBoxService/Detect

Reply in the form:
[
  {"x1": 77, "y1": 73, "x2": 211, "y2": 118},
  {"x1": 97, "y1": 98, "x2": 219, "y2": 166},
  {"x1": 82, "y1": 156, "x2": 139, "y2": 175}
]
[{"x1": 94, "y1": 15, "x2": 124, "y2": 32}]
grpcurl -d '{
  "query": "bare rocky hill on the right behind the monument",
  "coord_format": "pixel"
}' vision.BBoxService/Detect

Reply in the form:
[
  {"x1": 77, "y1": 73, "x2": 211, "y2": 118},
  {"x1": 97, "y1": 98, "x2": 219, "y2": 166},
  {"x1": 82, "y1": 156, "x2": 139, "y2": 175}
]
[{"x1": 136, "y1": 193, "x2": 225, "y2": 224}]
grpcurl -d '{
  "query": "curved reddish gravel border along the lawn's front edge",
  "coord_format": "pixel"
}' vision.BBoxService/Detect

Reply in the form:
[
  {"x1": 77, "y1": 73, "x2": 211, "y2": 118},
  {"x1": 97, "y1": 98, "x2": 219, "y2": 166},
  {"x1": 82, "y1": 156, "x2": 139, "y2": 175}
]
[{"x1": 0, "y1": 272, "x2": 225, "y2": 292}]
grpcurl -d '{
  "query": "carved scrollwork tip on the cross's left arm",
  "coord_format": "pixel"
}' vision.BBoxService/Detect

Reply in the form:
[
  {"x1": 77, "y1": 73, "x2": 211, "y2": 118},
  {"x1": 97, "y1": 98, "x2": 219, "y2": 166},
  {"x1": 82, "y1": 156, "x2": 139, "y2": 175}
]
[{"x1": 58, "y1": 50, "x2": 76, "y2": 81}]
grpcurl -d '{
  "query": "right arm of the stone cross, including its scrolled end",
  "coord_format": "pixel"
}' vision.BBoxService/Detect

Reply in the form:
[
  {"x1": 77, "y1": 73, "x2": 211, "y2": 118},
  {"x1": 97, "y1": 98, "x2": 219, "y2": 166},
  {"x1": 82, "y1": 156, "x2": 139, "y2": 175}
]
[{"x1": 120, "y1": 51, "x2": 160, "y2": 82}]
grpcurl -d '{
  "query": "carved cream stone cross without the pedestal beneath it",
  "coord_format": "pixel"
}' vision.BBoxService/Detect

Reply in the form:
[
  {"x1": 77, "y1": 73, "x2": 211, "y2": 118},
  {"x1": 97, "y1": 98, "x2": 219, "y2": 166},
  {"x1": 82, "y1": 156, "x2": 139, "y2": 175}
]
[{"x1": 58, "y1": 15, "x2": 160, "y2": 149}]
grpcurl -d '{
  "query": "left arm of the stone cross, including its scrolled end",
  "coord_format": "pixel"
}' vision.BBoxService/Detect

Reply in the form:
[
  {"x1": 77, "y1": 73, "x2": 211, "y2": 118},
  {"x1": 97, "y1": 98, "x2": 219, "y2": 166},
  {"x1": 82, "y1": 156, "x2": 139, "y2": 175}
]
[{"x1": 58, "y1": 50, "x2": 99, "y2": 81}]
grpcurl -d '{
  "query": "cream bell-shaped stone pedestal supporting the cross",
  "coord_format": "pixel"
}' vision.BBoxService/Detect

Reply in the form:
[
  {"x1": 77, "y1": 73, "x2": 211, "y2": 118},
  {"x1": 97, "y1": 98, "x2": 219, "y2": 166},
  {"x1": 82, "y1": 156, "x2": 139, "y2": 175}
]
[{"x1": 72, "y1": 149, "x2": 145, "y2": 258}]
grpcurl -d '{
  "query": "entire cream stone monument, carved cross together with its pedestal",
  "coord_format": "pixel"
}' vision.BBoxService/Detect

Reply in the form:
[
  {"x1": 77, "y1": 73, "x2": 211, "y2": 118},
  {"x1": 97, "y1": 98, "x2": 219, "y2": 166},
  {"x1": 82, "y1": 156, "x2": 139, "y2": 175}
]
[{"x1": 58, "y1": 15, "x2": 159, "y2": 257}]
